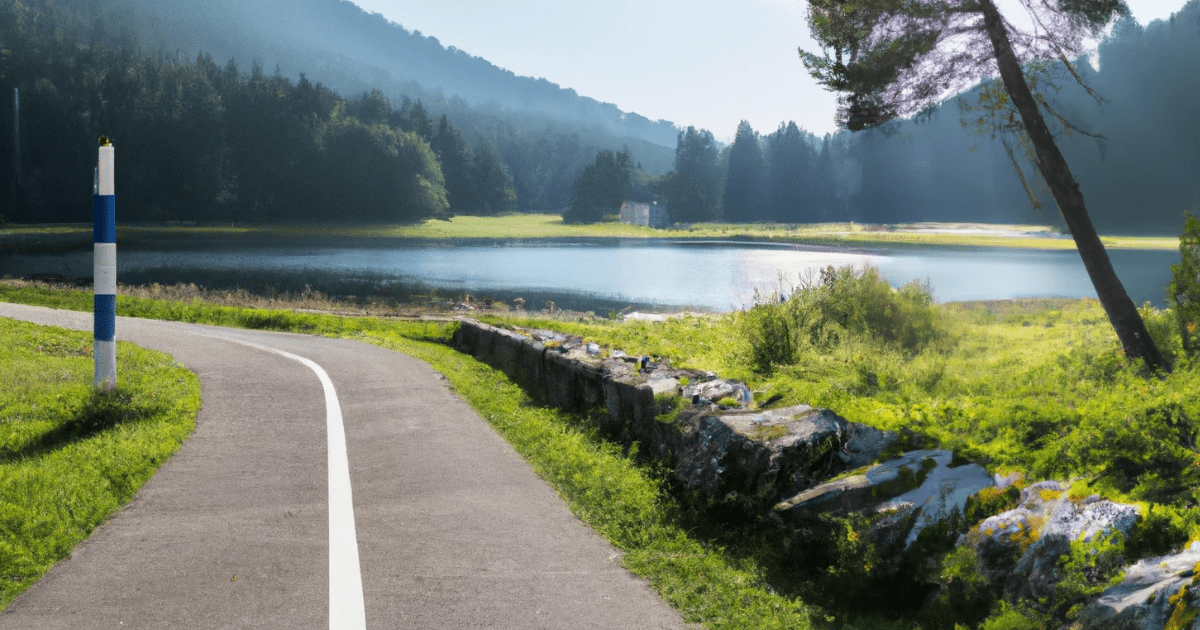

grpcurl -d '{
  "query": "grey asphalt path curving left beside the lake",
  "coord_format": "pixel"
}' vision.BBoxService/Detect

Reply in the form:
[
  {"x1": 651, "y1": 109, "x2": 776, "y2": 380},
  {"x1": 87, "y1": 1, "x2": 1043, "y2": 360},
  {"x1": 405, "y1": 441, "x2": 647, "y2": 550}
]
[{"x1": 0, "y1": 302, "x2": 688, "y2": 630}]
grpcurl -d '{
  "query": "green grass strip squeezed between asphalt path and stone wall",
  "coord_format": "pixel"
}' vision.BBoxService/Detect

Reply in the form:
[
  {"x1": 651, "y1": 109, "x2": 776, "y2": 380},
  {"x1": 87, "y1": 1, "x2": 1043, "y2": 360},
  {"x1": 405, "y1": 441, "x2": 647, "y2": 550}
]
[{"x1": 360, "y1": 335, "x2": 810, "y2": 630}]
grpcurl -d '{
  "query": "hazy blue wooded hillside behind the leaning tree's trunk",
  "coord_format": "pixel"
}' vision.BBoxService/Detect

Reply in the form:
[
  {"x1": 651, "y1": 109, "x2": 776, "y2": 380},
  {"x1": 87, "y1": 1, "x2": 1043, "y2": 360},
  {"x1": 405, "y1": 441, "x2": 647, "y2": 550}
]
[{"x1": 834, "y1": 0, "x2": 1200, "y2": 234}]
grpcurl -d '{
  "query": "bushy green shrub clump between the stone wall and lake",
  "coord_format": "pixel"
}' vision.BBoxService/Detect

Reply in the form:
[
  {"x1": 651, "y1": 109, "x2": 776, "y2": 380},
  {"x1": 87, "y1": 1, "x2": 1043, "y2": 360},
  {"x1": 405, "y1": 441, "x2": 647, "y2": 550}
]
[{"x1": 742, "y1": 265, "x2": 942, "y2": 372}]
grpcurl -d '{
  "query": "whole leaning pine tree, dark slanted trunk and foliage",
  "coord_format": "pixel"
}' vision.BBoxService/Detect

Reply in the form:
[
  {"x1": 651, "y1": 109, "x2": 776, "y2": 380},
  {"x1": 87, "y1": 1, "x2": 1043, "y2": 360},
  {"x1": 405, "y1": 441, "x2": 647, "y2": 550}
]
[{"x1": 800, "y1": 0, "x2": 1170, "y2": 371}]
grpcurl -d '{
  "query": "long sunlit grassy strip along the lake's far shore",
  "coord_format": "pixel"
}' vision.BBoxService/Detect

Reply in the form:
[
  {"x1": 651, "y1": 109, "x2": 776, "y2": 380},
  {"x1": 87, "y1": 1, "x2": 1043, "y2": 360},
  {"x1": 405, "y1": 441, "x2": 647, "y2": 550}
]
[{"x1": 0, "y1": 215, "x2": 1180, "y2": 252}]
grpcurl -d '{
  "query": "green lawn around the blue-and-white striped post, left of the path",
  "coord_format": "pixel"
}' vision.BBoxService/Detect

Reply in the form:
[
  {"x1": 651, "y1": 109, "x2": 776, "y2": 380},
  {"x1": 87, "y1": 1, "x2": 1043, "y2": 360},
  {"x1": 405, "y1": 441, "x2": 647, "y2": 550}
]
[{"x1": 0, "y1": 319, "x2": 200, "y2": 610}]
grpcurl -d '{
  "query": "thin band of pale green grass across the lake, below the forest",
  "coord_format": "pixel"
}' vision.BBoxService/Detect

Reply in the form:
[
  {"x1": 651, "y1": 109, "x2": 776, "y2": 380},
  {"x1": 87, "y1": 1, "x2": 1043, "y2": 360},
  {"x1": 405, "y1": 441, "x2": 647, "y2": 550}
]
[{"x1": 0, "y1": 215, "x2": 1178, "y2": 251}]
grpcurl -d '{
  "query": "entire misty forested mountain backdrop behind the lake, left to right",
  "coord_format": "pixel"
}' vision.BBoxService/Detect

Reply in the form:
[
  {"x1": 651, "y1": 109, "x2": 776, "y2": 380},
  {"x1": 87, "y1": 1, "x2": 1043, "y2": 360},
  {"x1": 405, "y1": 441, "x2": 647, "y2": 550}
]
[{"x1": 0, "y1": 0, "x2": 1200, "y2": 233}]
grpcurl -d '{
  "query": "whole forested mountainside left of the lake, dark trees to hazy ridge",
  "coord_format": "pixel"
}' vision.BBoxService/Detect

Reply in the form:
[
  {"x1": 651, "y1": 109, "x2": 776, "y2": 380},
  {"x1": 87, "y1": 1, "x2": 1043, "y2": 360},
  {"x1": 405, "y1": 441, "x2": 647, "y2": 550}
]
[{"x1": 0, "y1": 0, "x2": 673, "y2": 221}]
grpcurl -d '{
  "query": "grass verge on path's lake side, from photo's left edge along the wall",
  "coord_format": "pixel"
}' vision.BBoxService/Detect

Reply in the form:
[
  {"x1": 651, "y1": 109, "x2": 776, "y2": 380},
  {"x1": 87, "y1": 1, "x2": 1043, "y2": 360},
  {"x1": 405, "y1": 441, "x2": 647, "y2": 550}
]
[{"x1": 0, "y1": 283, "x2": 815, "y2": 630}]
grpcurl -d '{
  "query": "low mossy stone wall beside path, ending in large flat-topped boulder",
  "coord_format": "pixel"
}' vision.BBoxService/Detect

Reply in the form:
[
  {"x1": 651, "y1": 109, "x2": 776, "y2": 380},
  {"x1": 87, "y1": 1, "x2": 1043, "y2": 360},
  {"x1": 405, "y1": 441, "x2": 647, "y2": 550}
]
[{"x1": 451, "y1": 319, "x2": 895, "y2": 509}]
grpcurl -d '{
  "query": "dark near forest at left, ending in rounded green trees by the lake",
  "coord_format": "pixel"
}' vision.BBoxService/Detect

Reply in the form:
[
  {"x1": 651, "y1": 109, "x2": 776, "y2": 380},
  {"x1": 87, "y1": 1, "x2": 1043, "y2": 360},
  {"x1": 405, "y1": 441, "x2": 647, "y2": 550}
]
[{"x1": 0, "y1": 0, "x2": 450, "y2": 222}]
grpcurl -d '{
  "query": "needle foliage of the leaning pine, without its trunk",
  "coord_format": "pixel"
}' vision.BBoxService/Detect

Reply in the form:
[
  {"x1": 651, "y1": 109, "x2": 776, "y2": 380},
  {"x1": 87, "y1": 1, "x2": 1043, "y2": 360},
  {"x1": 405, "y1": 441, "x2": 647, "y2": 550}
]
[{"x1": 800, "y1": 0, "x2": 1128, "y2": 131}]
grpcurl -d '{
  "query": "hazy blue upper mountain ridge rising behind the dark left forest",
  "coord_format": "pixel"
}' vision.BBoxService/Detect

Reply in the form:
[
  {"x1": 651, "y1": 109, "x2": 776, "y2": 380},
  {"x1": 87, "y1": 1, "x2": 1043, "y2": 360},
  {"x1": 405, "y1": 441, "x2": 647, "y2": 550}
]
[{"x1": 87, "y1": 0, "x2": 677, "y2": 212}]
